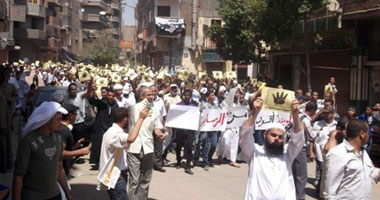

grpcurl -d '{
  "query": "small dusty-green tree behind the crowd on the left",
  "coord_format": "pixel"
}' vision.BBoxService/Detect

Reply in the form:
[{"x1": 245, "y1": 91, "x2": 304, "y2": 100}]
[{"x1": 83, "y1": 32, "x2": 119, "y2": 66}]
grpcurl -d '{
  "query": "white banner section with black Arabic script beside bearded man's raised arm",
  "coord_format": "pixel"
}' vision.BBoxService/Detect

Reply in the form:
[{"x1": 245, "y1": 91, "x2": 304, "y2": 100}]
[{"x1": 227, "y1": 106, "x2": 248, "y2": 128}]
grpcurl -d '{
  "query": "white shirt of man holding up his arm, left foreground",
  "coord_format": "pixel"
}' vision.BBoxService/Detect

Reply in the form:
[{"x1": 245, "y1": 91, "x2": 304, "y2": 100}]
[{"x1": 96, "y1": 123, "x2": 129, "y2": 190}]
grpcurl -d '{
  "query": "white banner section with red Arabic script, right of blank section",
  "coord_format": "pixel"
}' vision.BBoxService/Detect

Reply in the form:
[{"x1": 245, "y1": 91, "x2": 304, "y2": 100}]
[{"x1": 199, "y1": 109, "x2": 227, "y2": 131}]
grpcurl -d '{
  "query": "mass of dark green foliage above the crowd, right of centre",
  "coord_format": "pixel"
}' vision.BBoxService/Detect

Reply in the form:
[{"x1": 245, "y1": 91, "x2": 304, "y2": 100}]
[{"x1": 208, "y1": 0, "x2": 324, "y2": 63}]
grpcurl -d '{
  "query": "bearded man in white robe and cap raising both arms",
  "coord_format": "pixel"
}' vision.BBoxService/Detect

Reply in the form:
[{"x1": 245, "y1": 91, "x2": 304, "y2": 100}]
[{"x1": 240, "y1": 97, "x2": 305, "y2": 200}]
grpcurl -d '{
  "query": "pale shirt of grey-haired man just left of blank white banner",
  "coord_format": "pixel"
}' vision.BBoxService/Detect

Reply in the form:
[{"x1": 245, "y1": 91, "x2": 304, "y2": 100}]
[{"x1": 128, "y1": 100, "x2": 162, "y2": 155}]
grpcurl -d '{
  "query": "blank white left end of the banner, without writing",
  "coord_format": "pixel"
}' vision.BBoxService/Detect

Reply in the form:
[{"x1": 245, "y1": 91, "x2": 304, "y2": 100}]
[{"x1": 165, "y1": 105, "x2": 200, "y2": 131}]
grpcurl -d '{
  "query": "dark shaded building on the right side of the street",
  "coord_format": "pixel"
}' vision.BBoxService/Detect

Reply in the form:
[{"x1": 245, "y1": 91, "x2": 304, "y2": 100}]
[{"x1": 269, "y1": 0, "x2": 380, "y2": 115}]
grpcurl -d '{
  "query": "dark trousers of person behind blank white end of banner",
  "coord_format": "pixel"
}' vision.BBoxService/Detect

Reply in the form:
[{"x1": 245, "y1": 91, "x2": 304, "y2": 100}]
[{"x1": 176, "y1": 129, "x2": 194, "y2": 169}]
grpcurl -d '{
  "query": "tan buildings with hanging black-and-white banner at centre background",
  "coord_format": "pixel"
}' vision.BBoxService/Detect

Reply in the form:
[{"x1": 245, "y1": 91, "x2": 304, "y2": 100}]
[{"x1": 136, "y1": 0, "x2": 232, "y2": 74}]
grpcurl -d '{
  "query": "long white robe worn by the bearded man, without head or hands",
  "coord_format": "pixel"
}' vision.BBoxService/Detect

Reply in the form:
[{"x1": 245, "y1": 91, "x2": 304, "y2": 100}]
[{"x1": 240, "y1": 126, "x2": 305, "y2": 200}]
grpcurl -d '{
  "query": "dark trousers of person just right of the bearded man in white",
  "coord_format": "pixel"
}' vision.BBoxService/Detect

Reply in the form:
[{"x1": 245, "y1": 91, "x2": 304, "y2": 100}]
[{"x1": 292, "y1": 147, "x2": 307, "y2": 200}]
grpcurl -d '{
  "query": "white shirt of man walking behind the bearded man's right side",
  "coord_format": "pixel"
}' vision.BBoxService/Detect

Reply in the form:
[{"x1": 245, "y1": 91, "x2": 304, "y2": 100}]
[{"x1": 310, "y1": 120, "x2": 337, "y2": 162}]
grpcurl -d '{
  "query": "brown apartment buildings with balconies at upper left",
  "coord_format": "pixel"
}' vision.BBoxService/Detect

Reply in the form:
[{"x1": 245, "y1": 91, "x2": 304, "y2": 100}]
[{"x1": 0, "y1": 0, "x2": 122, "y2": 62}]
